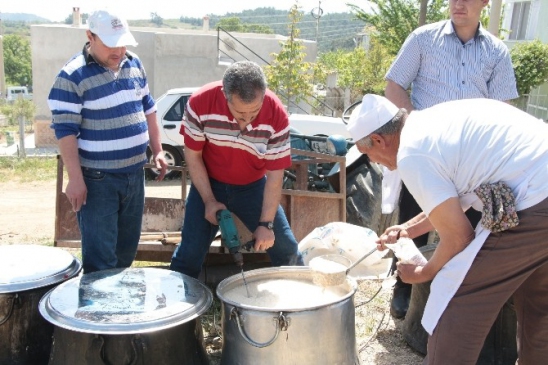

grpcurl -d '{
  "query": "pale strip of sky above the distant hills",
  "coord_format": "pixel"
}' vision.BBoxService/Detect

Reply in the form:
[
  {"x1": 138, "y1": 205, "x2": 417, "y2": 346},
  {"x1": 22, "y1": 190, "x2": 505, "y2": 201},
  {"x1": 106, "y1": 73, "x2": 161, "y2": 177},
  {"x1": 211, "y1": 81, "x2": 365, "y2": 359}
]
[{"x1": 0, "y1": 0, "x2": 367, "y2": 21}]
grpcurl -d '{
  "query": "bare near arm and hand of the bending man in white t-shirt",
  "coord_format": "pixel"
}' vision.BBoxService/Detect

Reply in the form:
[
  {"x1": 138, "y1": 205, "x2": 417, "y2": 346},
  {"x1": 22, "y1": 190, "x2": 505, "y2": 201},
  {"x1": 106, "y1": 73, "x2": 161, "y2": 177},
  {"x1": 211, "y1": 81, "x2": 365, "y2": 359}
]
[{"x1": 398, "y1": 198, "x2": 475, "y2": 283}]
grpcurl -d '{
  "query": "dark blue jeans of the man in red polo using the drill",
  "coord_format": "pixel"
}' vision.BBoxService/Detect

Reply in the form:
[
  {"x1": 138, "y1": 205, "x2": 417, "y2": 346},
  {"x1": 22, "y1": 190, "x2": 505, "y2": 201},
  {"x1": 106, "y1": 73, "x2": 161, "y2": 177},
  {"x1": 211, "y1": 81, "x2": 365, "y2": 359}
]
[{"x1": 170, "y1": 178, "x2": 304, "y2": 278}]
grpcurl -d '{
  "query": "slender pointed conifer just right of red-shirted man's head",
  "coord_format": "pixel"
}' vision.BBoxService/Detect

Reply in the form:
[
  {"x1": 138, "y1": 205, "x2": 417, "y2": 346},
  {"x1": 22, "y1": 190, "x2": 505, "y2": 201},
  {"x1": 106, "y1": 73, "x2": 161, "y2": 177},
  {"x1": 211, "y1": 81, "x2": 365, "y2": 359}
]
[{"x1": 265, "y1": 4, "x2": 313, "y2": 105}]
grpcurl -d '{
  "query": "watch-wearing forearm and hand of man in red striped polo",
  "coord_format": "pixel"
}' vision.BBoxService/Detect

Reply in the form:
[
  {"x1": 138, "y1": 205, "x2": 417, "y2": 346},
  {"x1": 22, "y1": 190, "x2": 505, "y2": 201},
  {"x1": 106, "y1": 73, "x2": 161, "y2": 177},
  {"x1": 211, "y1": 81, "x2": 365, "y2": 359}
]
[{"x1": 253, "y1": 170, "x2": 284, "y2": 250}]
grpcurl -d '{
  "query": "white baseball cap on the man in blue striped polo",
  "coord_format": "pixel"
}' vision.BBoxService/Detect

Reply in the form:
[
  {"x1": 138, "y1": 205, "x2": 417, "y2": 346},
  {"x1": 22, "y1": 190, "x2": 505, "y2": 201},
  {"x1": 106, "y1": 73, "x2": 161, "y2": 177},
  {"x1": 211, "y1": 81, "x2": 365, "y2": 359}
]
[{"x1": 87, "y1": 10, "x2": 137, "y2": 48}]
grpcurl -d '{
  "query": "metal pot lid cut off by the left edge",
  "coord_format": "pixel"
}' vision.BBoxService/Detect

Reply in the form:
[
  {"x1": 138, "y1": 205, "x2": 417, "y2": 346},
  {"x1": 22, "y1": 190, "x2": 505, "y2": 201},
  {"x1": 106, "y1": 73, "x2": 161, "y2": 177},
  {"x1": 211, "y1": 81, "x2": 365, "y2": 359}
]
[{"x1": 0, "y1": 245, "x2": 82, "y2": 294}]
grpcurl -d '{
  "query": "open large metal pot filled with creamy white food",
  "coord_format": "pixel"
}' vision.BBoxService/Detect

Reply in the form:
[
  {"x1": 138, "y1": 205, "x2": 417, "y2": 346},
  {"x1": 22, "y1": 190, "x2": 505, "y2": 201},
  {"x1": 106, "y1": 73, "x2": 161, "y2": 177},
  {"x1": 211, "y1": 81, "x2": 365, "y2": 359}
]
[{"x1": 217, "y1": 267, "x2": 360, "y2": 365}]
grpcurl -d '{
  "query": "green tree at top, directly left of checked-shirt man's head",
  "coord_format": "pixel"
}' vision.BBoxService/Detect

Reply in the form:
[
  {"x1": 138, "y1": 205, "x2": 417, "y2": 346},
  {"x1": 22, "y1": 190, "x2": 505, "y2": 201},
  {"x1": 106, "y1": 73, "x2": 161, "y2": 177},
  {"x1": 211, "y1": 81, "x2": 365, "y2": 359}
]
[{"x1": 348, "y1": 0, "x2": 448, "y2": 55}]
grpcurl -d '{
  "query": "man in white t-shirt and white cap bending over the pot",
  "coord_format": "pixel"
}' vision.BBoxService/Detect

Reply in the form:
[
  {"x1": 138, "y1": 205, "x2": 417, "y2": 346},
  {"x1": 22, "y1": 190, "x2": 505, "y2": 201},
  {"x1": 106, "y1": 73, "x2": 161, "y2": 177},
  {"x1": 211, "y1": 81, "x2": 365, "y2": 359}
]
[{"x1": 348, "y1": 95, "x2": 548, "y2": 364}]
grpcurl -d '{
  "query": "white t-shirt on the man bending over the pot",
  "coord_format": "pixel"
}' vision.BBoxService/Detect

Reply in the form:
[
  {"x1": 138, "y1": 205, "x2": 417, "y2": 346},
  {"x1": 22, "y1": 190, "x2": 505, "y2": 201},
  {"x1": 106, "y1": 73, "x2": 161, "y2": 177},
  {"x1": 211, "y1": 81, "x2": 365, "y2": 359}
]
[{"x1": 398, "y1": 99, "x2": 548, "y2": 215}]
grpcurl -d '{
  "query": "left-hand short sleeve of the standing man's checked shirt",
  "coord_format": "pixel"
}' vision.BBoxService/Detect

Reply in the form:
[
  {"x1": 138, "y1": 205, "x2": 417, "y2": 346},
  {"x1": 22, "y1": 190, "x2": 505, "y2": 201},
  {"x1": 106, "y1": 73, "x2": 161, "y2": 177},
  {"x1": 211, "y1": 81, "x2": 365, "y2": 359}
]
[{"x1": 385, "y1": 33, "x2": 421, "y2": 90}]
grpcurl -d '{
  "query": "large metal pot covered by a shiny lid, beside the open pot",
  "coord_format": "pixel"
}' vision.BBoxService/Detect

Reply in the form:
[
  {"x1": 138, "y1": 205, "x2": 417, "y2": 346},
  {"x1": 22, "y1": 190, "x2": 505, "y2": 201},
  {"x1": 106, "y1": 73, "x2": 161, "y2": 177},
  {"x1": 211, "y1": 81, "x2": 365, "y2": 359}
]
[{"x1": 39, "y1": 268, "x2": 213, "y2": 365}]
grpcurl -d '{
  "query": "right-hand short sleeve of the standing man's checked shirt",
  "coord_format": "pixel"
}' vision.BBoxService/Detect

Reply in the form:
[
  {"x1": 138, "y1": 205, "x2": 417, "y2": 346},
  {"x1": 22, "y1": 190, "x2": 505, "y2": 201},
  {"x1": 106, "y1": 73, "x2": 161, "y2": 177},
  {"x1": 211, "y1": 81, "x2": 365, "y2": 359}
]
[{"x1": 488, "y1": 46, "x2": 518, "y2": 101}]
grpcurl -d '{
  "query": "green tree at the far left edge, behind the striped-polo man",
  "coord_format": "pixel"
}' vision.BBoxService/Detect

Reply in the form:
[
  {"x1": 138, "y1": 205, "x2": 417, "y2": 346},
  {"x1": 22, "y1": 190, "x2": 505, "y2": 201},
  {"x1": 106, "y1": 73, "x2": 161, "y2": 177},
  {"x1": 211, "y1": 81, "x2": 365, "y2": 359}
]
[{"x1": 3, "y1": 34, "x2": 32, "y2": 85}]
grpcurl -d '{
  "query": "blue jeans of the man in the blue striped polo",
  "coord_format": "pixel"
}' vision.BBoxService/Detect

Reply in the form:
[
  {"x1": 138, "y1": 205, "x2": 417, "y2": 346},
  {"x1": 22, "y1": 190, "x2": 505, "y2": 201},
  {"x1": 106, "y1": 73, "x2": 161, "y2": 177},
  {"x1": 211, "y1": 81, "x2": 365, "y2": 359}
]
[{"x1": 77, "y1": 167, "x2": 145, "y2": 273}]
